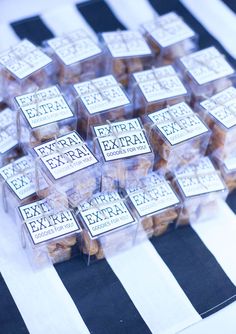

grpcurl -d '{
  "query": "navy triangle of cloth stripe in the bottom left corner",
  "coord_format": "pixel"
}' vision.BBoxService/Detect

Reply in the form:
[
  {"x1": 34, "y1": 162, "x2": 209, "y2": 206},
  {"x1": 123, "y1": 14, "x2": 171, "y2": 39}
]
[{"x1": 0, "y1": 274, "x2": 29, "y2": 334}]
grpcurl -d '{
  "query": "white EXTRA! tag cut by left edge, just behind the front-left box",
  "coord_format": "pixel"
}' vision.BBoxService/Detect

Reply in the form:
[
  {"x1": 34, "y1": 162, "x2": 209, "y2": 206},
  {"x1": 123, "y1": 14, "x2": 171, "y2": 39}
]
[{"x1": 0, "y1": 155, "x2": 46, "y2": 200}]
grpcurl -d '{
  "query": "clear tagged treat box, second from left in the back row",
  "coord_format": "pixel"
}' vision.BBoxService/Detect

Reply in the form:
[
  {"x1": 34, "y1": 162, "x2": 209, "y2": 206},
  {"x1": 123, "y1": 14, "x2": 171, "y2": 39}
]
[{"x1": 44, "y1": 29, "x2": 102, "y2": 86}]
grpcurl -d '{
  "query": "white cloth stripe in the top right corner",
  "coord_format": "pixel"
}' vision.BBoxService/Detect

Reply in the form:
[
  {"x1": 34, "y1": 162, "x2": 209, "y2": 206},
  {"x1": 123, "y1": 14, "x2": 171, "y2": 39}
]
[{"x1": 181, "y1": 0, "x2": 236, "y2": 58}]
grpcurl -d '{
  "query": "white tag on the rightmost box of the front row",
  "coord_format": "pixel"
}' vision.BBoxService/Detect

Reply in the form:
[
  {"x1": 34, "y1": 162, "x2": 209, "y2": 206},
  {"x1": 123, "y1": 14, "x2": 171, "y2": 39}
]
[{"x1": 175, "y1": 157, "x2": 225, "y2": 197}]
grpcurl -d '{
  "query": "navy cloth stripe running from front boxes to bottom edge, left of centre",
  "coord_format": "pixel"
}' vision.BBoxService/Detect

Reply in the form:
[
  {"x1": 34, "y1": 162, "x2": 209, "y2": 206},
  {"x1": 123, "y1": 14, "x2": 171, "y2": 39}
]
[{"x1": 55, "y1": 257, "x2": 151, "y2": 334}]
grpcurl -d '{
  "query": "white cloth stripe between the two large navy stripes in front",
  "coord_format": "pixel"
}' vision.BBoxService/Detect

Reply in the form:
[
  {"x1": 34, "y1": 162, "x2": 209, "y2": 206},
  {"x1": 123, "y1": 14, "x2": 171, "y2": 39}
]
[{"x1": 107, "y1": 241, "x2": 201, "y2": 334}]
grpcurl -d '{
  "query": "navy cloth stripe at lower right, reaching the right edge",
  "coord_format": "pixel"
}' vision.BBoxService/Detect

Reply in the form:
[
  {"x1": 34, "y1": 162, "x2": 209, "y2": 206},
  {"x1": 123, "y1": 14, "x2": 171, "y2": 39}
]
[{"x1": 151, "y1": 226, "x2": 236, "y2": 318}]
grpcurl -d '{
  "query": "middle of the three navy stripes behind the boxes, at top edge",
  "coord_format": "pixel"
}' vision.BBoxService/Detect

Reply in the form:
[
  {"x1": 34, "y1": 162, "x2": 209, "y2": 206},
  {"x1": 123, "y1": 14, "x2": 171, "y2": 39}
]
[{"x1": 76, "y1": 0, "x2": 125, "y2": 33}]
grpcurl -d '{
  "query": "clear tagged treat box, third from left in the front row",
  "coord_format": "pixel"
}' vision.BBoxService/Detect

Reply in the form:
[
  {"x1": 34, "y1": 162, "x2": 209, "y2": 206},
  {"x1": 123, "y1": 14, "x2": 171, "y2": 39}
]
[{"x1": 123, "y1": 172, "x2": 181, "y2": 239}]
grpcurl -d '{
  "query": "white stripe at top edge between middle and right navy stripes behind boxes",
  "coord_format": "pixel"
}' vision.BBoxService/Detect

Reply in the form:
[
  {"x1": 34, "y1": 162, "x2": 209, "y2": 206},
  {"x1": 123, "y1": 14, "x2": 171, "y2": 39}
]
[{"x1": 106, "y1": 0, "x2": 158, "y2": 29}]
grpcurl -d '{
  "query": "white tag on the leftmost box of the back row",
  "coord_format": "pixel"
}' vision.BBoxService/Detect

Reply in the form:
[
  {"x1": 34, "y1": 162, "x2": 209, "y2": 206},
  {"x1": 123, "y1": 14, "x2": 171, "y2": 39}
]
[{"x1": 0, "y1": 39, "x2": 52, "y2": 79}]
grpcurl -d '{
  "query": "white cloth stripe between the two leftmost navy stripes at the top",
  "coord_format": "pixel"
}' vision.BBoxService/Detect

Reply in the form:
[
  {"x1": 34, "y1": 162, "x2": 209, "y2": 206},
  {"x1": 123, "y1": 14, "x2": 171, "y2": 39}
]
[{"x1": 41, "y1": 5, "x2": 97, "y2": 39}]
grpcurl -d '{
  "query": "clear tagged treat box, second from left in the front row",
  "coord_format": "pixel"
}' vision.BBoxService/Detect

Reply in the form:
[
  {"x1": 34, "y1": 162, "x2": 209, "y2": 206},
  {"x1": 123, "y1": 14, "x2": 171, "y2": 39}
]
[{"x1": 77, "y1": 191, "x2": 137, "y2": 265}]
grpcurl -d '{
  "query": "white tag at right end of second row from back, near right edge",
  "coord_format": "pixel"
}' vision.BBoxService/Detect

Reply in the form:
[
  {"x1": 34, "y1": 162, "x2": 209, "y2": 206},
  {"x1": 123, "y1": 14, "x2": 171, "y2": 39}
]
[{"x1": 180, "y1": 46, "x2": 234, "y2": 85}]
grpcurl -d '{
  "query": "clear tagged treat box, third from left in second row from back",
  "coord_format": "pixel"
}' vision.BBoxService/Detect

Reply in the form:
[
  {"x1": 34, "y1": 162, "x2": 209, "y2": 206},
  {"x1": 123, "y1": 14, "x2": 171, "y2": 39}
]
[{"x1": 129, "y1": 65, "x2": 190, "y2": 116}]
